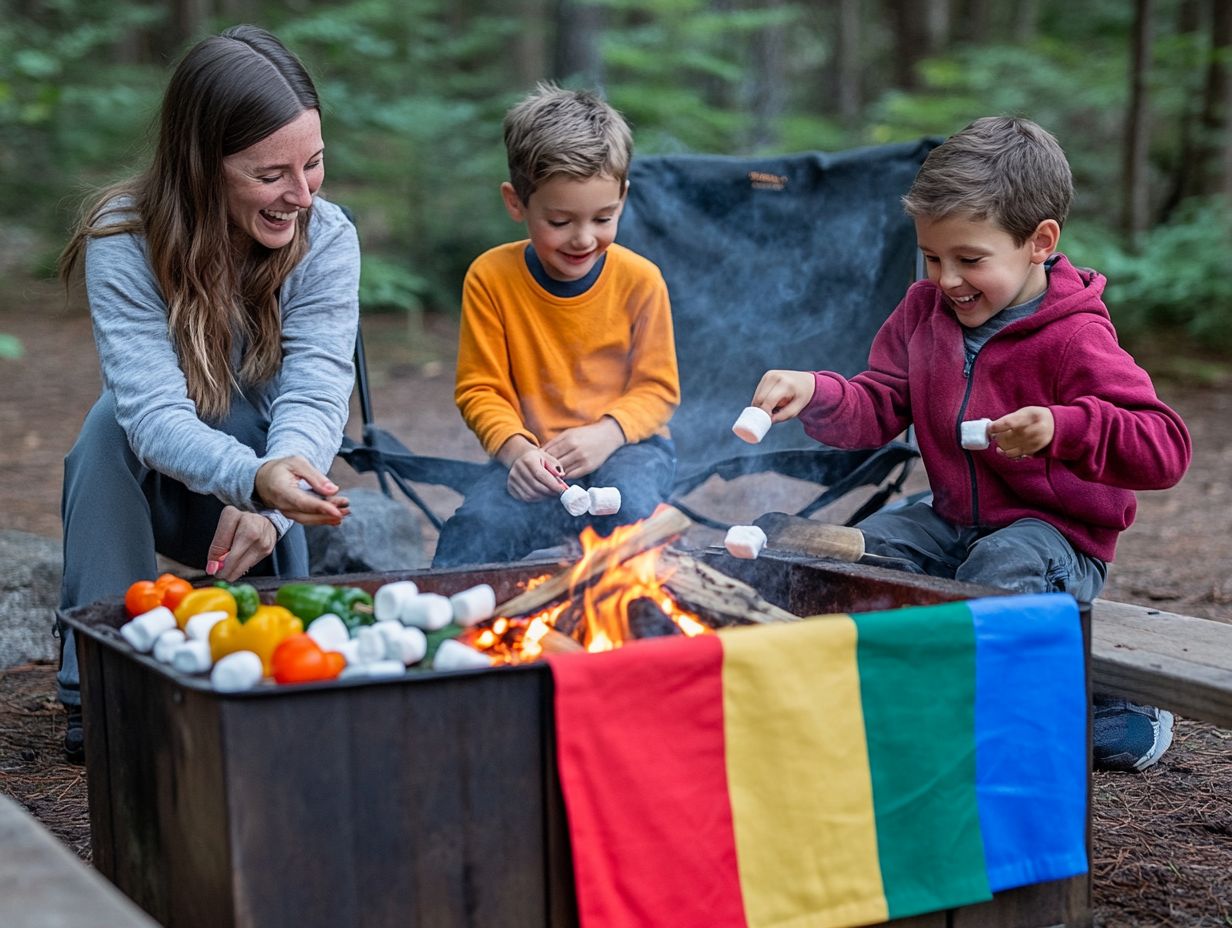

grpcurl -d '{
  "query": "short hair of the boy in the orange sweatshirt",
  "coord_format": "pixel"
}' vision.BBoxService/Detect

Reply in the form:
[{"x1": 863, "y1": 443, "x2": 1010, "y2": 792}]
[{"x1": 504, "y1": 83, "x2": 633, "y2": 203}]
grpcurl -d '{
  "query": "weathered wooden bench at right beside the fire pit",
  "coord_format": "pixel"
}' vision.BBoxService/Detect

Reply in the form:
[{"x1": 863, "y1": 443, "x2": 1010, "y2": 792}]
[{"x1": 1090, "y1": 599, "x2": 1232, "y2": 728}]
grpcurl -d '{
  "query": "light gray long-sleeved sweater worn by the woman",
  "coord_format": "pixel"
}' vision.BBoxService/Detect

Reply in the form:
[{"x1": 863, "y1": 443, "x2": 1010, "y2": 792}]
[{"x1": 85, "y1": 197, "x2": 360, "y2": 536}]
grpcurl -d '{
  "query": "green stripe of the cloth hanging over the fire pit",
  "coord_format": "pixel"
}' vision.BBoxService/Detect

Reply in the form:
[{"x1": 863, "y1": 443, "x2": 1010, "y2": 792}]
[{"x1": 853, "y1": 603, "x2": 992, "y2": 918}]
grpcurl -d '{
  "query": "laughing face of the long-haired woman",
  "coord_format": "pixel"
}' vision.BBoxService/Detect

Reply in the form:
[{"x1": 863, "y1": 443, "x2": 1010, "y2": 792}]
[{"x1": 223, "y1": 110, "x2": 325, "y2": 249}]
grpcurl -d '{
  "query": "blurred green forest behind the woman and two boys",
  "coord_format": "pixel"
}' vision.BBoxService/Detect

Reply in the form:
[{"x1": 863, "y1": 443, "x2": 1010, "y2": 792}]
[{"x1": 0, "y1": 0, "x2": 1232, "y2": 362}]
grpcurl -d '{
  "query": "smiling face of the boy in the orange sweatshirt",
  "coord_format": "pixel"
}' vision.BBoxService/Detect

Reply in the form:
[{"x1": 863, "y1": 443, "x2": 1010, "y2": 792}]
[{"x1": 500, "y1": 175, "x2": 625, "y2": 281}]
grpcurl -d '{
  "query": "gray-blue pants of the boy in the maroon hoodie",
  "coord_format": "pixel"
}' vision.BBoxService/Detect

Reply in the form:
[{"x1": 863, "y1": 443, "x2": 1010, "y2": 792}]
[{"x1": 856, "y1": 503, "x2": 1108, "y2": 603}]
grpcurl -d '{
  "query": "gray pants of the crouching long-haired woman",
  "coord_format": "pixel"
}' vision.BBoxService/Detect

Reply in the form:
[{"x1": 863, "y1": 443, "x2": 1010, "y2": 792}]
[{"x1": 57, "y1": 392, "x2": 308, "y2": 705}]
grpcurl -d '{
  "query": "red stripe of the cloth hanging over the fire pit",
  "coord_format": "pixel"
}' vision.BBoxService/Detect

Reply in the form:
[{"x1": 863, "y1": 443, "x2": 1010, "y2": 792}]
[{"x1": 549, "y1": 636, "x2": 745, "y2": 928}]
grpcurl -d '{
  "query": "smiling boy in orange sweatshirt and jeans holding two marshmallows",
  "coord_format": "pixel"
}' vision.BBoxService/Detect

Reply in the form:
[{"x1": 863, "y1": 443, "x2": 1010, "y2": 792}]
[{"x1": 432, "y1": 84, "x2": 680, "y2": 567}]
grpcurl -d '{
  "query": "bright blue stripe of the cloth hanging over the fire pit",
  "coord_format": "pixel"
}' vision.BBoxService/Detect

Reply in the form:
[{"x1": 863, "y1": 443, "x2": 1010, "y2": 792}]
[{"x1": 967, "y1": 593, "x2": 1088, "y2": 892}]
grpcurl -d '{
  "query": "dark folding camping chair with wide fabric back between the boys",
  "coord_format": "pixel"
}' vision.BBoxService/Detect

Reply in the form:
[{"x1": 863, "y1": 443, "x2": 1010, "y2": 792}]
[{"x1": 616, "y1": 139, "x2": 936, "y2": 529}]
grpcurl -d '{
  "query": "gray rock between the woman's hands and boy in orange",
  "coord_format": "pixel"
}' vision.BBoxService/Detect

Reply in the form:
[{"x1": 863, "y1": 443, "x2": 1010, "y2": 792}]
[{"x1": 304, "y1": 488, "x2": 428, "y2": 577}]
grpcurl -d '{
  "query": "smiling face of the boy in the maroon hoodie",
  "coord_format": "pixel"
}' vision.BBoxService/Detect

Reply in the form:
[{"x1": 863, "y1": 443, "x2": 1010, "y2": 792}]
[{"x1": 915, "y1": 216, "x2": 1061, "y2": 329}]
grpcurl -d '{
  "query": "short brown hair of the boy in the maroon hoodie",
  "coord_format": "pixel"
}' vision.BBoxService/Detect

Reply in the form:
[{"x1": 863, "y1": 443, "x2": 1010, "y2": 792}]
[{"x1": 903, "y1": 116, "x2": 1074, "y2": 245}]
